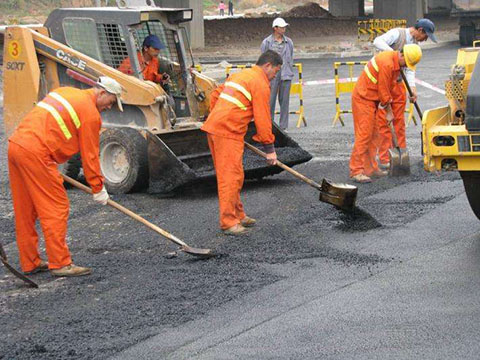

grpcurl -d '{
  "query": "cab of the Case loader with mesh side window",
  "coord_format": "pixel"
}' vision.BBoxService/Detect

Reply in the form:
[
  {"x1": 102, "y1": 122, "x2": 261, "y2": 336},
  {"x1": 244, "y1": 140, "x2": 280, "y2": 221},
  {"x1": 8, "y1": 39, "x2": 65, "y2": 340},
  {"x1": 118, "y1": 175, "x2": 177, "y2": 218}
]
[{"x1": 45, "y1": 7, "x2": 196, "y2": 118}]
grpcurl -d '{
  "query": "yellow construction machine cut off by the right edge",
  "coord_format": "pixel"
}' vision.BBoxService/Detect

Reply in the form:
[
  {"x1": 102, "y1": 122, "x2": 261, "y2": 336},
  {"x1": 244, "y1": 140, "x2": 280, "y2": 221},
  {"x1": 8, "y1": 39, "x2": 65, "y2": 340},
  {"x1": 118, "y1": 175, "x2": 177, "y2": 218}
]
[{"x1": 422, "y1": 44, "x2": 480, "y2": 219}]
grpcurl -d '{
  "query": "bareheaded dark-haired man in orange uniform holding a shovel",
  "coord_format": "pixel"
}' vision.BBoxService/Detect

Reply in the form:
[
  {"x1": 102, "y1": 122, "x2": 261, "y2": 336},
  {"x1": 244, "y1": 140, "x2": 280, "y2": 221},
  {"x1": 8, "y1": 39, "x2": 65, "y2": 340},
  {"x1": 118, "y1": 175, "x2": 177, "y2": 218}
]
[{"x1": 202, "y1": 50, "x2": 282, "y2": 235}]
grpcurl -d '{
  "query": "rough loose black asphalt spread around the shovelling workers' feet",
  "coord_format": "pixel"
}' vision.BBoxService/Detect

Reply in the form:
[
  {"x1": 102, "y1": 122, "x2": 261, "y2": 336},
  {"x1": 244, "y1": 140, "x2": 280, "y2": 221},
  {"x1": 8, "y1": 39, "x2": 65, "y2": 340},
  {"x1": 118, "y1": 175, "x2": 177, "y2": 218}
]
[{"x1": 0, "y1": 122, "x2": 457, "y2": 359}]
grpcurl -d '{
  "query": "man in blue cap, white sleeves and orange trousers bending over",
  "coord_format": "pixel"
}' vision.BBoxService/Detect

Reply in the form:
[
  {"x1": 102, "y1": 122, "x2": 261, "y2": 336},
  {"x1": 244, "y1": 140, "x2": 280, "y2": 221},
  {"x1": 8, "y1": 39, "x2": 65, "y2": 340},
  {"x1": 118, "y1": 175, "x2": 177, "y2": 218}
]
[{"x1": 373, "y1": 19, "x2": 437, "y2": 170}]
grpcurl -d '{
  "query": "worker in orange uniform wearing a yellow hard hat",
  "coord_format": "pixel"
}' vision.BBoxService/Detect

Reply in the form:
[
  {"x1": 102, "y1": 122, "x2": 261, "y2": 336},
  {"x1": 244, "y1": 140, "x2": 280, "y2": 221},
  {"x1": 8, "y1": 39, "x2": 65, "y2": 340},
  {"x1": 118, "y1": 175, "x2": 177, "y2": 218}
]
[{"x1": 350, "y1": 44, "x2": 422, "y2": 183}]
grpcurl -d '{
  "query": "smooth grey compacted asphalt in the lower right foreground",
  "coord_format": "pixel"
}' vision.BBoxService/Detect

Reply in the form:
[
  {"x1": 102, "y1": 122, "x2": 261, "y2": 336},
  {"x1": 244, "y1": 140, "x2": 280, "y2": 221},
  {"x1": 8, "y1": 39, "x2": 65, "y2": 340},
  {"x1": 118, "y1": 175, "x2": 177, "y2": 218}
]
[{"x1": 113, "y1": 191, "x2": 480, "y2": 359}]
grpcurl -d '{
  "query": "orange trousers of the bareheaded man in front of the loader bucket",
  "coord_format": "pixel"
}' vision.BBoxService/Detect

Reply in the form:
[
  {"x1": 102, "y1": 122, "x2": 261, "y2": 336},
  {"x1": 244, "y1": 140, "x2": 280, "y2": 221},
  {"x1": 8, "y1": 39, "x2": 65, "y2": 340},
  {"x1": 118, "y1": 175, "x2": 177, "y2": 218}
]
[{"x1": 207, "y1": 134, "x2": 245, "y2": 230}]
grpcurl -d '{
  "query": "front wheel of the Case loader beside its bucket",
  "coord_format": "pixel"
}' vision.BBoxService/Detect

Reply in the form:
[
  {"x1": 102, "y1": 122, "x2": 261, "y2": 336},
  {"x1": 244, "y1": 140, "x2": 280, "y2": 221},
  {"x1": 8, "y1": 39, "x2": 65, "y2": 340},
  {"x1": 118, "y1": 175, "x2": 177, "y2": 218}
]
[{"x1": 100, "y1": 128, "x2": 148, "y2": 194}]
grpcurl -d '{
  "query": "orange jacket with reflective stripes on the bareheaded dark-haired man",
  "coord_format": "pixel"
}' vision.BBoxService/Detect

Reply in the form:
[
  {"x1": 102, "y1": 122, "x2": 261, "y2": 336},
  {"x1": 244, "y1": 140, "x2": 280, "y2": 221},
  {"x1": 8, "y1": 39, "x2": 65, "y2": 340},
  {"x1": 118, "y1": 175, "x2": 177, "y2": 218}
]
[{"x1": 202, "y1": 65, "x2": 275, "y2": 144}]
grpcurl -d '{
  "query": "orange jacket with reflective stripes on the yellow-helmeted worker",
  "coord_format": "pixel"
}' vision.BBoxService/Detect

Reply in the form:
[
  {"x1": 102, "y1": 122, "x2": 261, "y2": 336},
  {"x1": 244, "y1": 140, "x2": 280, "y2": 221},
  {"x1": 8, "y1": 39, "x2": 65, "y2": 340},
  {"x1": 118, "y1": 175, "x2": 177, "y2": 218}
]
[{"x1": 354, "y1": 51, "x2": 400, "y2": 105}]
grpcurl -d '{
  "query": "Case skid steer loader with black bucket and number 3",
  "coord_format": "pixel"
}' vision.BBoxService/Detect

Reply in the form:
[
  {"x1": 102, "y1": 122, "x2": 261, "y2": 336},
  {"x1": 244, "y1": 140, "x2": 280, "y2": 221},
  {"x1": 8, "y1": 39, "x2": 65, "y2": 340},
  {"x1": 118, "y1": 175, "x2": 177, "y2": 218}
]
[{"x1": 3, "y1": 0, "x2": 311, "y2": 193}]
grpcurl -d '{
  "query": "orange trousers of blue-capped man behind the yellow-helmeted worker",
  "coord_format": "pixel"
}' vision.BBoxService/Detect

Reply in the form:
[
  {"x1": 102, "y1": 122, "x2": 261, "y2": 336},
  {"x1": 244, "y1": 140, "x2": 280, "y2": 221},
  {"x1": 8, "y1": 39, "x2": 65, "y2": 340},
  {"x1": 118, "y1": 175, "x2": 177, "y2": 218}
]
[{"x1": 375, "y1": 82, "x2": 407, "y2": 164}]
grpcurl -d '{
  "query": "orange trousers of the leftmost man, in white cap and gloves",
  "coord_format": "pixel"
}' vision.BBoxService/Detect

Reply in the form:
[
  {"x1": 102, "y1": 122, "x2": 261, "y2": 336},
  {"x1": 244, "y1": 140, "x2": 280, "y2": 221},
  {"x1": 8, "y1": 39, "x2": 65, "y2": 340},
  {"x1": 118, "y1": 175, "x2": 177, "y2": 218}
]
[{"x1": 8, "y1": 142, "x2": 72, "y2": 272}]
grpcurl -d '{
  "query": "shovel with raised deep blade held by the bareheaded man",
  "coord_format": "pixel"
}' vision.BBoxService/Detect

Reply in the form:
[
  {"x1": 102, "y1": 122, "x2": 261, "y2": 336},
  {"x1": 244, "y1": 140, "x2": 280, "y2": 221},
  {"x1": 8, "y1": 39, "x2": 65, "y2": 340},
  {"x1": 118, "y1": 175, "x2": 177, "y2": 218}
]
[{"x1": 245, "y1": 142, "x2": 358, "y2": 211}]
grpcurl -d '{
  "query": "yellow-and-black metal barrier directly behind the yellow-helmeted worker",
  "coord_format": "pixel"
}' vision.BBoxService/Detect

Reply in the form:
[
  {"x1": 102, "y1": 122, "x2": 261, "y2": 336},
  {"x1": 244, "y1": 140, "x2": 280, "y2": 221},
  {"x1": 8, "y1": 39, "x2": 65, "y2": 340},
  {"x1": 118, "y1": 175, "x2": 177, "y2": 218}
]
[{"x1": 332, "y1": 61, "x2": 417, "y2": 127}]
